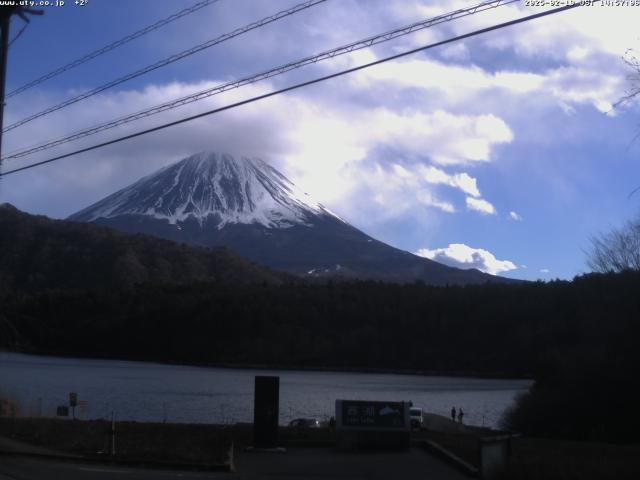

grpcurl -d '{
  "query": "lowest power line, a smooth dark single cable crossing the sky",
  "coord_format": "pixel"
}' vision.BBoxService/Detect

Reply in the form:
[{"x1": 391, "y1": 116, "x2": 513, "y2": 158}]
[{"x1": 0, "y1": 3, "x2": 581, "y2": 178}]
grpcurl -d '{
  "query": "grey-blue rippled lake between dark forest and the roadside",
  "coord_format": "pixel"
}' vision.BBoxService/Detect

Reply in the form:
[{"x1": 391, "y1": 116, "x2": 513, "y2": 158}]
[{"x1": 0, "y1": 352, "x2": 531, "y2": 426}]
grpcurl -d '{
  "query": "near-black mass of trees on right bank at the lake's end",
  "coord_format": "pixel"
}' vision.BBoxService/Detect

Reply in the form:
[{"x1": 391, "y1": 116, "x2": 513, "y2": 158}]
[{"x1": 503, "y1": 272, "x2": 640, "y2": 443}]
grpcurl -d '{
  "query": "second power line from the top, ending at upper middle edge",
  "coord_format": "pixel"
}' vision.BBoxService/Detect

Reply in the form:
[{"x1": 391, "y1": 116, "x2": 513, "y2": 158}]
[{"x1": 4, "y1": 0, "x2": 327, "y2": 132}]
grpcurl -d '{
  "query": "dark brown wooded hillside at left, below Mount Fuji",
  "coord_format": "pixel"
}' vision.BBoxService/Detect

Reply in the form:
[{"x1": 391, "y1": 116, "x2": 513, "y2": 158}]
[{"x1": 0, "y1": 204, "x2": 282, "y2": 291}]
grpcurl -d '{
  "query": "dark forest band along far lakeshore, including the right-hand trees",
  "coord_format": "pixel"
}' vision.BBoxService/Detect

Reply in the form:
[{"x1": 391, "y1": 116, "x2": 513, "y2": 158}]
[{"x1": 0, "y1": 272, "x2": 640, "y2": 440}]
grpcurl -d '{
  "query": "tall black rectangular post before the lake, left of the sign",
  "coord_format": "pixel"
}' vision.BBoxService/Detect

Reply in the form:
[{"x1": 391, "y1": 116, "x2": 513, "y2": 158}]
[{"x1": 253, "y1": 376, "x2": 280, "y2": 448}]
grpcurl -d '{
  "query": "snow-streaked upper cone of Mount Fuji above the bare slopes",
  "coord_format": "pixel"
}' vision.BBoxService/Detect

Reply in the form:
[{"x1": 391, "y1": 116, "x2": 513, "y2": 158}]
[{"x1": 71, "y1": 152, "x2": 340, "y2": 229}]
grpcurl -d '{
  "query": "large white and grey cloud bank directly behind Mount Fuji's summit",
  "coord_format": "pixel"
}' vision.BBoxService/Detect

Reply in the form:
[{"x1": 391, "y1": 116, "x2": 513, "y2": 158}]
[{"x1": 3, "y1": 82, "x2": 484, "y2": 216}]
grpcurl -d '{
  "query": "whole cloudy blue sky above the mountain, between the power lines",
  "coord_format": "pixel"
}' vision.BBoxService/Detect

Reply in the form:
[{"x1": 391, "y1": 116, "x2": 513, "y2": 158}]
[{"x1": 0, "y1": 0, "x2": 640, "y2": 279}]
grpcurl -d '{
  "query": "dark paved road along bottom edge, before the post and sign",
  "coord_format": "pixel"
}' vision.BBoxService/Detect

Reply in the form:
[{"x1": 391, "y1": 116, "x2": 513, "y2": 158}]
[{"x1": 0, "y1": 448, "x2": 467, "y2": 480}]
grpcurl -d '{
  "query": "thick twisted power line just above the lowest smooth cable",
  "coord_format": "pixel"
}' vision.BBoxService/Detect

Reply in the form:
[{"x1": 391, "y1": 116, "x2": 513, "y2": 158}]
[{"x1": 3, "y1": 0, "x2": 519, "y2": 160}]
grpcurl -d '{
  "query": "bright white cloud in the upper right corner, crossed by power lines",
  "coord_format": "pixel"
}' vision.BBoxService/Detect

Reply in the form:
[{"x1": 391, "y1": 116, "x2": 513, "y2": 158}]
[{"x1": 344, "y1": 0, "x2": 639, "y2": 113}]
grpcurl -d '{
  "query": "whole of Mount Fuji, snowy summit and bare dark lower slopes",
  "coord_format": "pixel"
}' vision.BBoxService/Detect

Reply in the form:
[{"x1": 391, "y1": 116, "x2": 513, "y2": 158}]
[{"x1": 69, "y1": 152, "x2": 510, "y2": 285}]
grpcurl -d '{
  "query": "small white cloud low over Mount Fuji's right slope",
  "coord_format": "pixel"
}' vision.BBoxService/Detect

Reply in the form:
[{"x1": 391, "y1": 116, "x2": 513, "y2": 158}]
[{"x1": 416, "y1": 243, "x2": 518, "y2": 275}]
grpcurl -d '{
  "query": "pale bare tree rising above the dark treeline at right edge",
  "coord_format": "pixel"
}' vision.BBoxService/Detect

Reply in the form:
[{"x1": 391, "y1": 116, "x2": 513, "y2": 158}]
[{"x1": 587, "y1": 216, "x2": 640, "y2": 273}]
